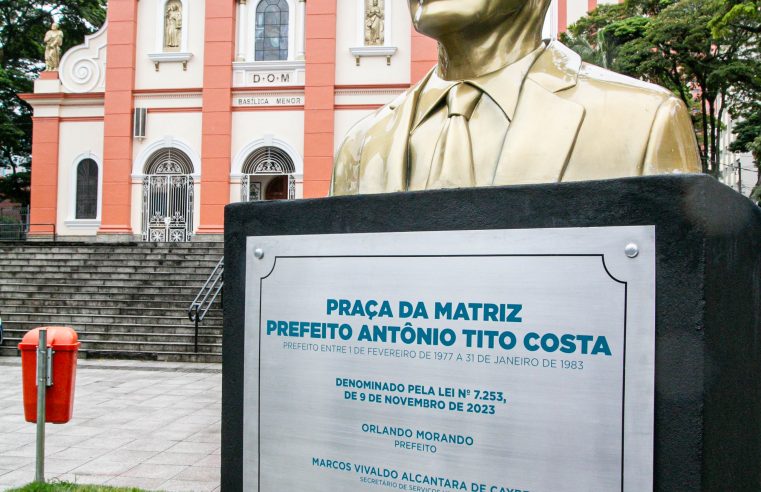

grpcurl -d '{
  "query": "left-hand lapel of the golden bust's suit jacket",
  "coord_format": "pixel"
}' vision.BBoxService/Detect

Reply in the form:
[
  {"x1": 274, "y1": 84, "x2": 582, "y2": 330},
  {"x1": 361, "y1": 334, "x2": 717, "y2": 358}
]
[{"x1": 359, "y1": 70, "x2": 433, "y2": 193}]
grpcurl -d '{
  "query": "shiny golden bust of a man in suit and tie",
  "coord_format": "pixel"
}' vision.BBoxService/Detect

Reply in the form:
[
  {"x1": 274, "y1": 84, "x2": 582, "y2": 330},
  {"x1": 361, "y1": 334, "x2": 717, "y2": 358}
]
[{"x1": 331, "y1": 0, "x2": 700, "y2": 195}]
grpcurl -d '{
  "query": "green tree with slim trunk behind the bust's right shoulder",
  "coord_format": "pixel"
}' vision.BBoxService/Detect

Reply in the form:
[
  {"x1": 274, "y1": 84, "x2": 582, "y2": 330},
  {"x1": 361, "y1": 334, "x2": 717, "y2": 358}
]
[{"x1": 569, "y1": 0, "x2": 761, "y2": 176}]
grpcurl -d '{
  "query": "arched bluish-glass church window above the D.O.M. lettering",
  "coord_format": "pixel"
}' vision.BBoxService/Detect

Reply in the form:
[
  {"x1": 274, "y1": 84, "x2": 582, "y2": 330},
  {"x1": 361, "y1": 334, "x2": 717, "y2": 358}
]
[{"x1": 254, "y1": 0, "x2": 288, "y2": 61}]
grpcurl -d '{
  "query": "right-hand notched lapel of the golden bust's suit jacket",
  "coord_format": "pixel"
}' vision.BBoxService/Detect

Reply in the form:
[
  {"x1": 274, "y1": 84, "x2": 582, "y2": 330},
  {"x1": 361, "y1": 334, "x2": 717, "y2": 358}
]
[{"x1": 493, "y1": 43, "x2": 585, "y2": 185}]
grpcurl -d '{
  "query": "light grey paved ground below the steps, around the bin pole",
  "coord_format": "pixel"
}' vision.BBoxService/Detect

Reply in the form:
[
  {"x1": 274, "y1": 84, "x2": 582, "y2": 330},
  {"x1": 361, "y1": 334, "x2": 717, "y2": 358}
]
[{"x1": 0, "y1": 357, "x2": 222, "y2": 492}]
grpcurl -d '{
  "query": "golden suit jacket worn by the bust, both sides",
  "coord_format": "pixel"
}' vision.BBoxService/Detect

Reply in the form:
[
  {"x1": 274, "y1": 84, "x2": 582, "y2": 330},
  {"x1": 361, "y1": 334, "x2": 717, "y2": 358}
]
[{"x1": 331, "y1": 42, "x2": 700, "y2": 195}]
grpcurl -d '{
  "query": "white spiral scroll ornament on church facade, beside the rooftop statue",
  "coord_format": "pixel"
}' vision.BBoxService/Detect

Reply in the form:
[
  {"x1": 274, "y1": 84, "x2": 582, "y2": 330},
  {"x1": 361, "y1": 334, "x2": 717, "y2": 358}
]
[{"x1": 59, "y1": 24, "x2": 108, "y2": 93}]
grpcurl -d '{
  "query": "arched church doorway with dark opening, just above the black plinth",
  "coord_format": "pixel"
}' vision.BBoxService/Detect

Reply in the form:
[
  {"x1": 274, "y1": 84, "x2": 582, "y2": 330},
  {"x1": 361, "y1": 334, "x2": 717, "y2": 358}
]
[{"x1": 241, "y1": 147, "x2": 296, "y2": 202}]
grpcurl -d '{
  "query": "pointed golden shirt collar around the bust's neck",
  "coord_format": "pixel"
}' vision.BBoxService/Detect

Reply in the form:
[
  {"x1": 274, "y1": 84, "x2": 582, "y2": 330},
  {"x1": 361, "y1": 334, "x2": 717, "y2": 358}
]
[{"x1": 413, "y1": 44, "x2": 545, "y2": 128}]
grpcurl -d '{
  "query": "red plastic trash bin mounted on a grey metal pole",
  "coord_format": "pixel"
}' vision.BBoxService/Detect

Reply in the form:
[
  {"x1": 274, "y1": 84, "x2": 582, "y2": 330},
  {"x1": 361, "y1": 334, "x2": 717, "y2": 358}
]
[{"x1": 18, "y1": 326, "x2": 80, "y2": 424}]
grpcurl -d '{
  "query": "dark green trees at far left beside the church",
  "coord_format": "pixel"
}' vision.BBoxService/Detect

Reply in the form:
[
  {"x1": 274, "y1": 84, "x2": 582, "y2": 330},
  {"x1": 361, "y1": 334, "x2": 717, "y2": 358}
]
[{"x1": 0, "y1": 0, "x2": 106, "y2": 203}]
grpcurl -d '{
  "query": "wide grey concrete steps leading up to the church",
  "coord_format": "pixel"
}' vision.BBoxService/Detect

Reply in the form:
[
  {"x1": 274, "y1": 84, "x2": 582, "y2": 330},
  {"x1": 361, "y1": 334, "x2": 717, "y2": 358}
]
[{"x1": 0, "y1": 242, "x2": 224, "y2": 362}]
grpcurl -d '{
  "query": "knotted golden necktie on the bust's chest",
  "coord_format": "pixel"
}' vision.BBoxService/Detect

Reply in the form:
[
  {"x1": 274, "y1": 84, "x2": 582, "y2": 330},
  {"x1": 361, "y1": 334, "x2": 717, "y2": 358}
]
[{"x1": 426, "y1": 82, "x2": 481, "y2": 189}]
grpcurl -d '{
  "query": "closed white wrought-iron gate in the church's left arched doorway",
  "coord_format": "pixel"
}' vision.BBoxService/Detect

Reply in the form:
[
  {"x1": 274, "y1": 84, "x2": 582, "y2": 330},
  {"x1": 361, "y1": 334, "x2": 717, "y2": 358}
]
[{"x1": 143, "y1": 174, "x2": 193, "y2": 243}]
